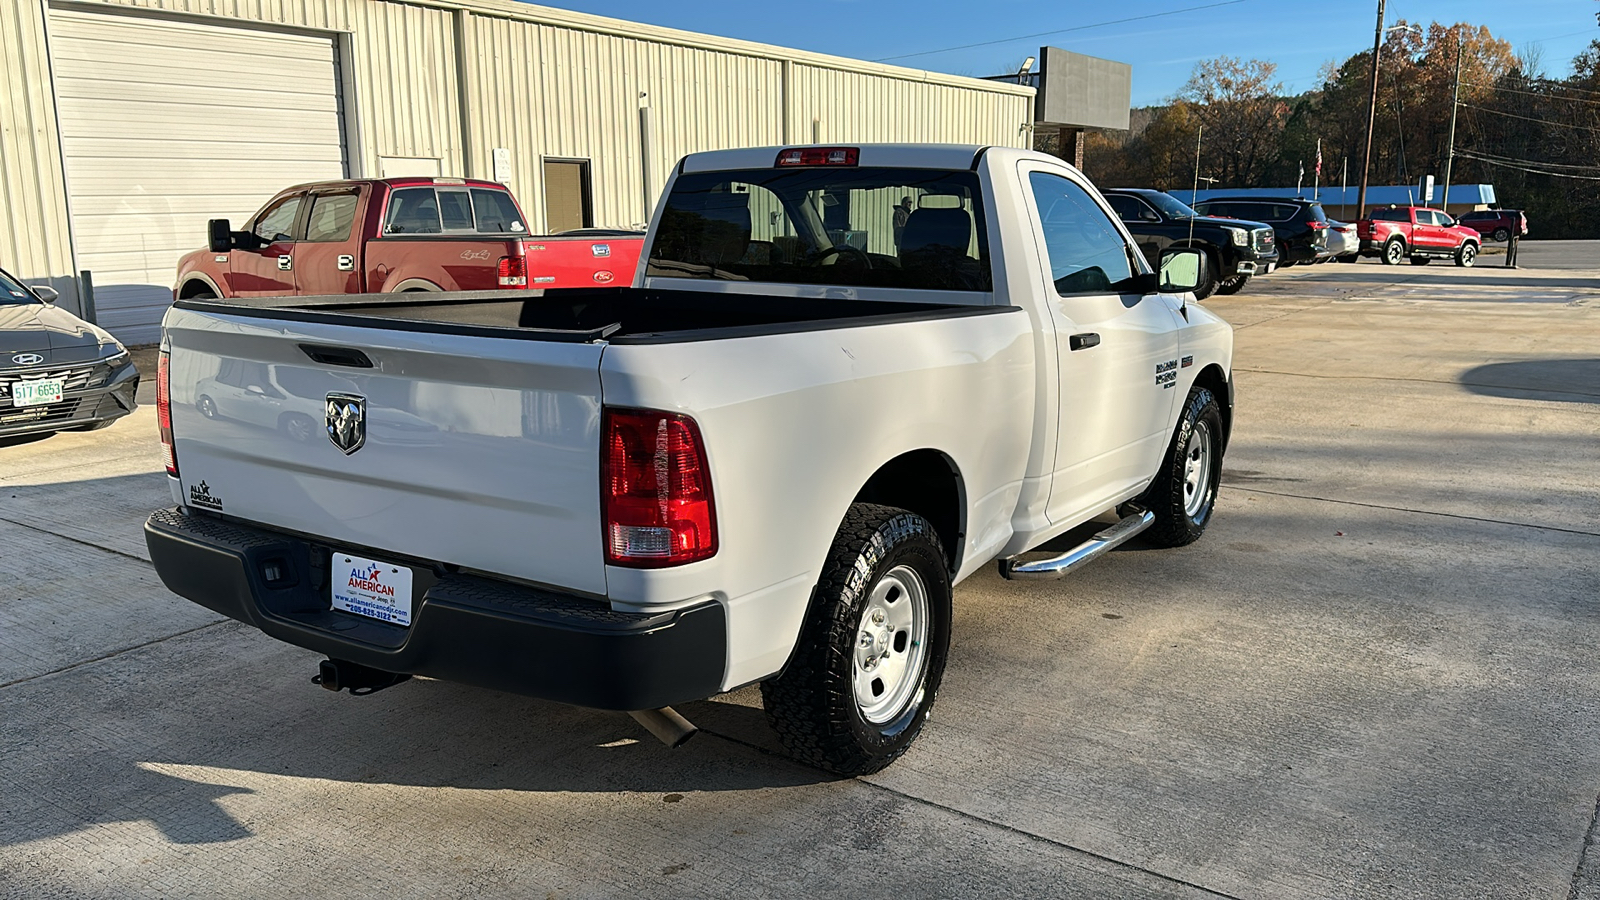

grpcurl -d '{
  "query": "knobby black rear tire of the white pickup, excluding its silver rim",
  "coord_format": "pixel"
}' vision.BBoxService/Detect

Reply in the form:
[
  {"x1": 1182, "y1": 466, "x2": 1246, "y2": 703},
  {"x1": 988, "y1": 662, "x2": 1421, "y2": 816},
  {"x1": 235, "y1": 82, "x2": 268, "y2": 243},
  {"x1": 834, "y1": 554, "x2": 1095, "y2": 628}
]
[{"x1": 762, "y1": 503, "x2": 950, "y2": 777}]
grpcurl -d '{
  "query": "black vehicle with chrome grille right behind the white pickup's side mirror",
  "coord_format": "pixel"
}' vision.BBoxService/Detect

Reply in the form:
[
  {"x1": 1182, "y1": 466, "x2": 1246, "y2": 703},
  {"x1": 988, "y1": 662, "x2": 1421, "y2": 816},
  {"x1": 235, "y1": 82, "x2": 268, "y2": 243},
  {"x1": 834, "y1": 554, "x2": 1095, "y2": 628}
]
[{"x1": 1101, "y1": 187, "x2": 1278, "y2": 299}]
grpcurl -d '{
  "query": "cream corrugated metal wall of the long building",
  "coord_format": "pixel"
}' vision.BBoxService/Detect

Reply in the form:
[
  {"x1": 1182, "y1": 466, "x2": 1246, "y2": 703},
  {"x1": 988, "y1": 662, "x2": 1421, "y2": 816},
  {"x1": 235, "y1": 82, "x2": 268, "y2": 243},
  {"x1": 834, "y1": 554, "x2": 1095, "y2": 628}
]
[{"x1": 0, "y1": 0, "x2": 1032, "y2": 318}]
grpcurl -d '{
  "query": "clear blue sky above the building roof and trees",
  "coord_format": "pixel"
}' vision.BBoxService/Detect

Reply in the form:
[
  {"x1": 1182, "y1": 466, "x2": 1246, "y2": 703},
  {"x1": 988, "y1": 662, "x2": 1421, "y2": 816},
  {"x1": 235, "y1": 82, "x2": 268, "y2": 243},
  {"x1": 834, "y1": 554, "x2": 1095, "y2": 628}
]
[{"x1": 542, "y1": 0, "x2": 1600, "y2": 106}]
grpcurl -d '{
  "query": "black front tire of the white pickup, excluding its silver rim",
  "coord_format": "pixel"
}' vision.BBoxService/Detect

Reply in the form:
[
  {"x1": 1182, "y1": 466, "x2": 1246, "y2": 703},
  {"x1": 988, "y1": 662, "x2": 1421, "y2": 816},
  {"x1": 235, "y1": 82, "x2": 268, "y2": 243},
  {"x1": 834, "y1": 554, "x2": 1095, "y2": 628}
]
[{"x1": 1134, "y1": 384, "x2": 1222, "y2": 546}]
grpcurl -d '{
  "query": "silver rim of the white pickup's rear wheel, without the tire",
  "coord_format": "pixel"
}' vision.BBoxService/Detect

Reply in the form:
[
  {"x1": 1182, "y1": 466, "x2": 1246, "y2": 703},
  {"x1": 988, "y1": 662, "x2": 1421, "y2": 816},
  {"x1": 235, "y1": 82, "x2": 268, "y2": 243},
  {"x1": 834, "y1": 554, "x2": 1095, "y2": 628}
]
[{"x1": 853, "y1": 565, "x2": 928, "y2": 725}]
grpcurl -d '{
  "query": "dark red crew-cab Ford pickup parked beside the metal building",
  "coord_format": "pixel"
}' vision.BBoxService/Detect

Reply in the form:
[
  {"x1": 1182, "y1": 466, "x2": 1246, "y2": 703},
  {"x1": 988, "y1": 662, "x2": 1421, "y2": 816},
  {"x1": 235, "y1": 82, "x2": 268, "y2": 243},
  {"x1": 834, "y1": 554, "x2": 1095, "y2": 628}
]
[{"x1": 173, "y1": 178, "x2": 643, "y2": 299}]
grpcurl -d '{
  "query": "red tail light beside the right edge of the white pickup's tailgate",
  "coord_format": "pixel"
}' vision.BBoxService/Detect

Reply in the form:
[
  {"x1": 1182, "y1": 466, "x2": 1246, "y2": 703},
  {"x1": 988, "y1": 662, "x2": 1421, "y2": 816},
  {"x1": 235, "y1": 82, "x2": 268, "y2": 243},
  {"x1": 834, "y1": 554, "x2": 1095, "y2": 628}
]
[{"x1": 600, "y1": 408, "x2": 717, "y2": 569}]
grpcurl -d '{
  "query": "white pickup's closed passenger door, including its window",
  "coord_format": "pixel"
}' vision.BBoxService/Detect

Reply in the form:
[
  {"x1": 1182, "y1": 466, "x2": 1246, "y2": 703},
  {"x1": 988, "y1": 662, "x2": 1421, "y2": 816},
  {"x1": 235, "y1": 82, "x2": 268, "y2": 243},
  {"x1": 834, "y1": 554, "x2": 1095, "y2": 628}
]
[{"x1": 1022, "y1": 163, "x2": 1179, "y2": 522}]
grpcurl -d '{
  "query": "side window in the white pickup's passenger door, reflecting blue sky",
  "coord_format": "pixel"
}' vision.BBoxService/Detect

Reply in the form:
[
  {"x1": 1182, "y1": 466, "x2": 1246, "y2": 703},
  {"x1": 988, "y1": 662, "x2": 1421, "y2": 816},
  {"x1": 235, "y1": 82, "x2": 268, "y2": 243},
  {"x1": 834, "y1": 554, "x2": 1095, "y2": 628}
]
[{"x1": 1027, "y1": 171, "x2": 1133, "y2": 296}]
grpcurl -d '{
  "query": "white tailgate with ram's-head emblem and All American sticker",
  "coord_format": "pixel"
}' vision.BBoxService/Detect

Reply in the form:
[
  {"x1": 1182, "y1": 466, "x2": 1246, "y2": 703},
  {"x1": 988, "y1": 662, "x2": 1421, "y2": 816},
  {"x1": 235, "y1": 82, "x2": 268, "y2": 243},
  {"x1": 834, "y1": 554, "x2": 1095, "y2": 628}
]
[{"x1": 166, "y1": 309, "x2": 606, "y2": 594}]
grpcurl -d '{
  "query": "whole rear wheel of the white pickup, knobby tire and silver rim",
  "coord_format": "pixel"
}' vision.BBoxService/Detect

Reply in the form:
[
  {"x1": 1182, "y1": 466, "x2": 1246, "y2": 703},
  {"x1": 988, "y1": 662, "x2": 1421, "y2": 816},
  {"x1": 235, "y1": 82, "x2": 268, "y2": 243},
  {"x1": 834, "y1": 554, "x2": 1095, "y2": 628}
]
[{"x1": 762, "y1": 503, "x2": 950, "y2": 775}]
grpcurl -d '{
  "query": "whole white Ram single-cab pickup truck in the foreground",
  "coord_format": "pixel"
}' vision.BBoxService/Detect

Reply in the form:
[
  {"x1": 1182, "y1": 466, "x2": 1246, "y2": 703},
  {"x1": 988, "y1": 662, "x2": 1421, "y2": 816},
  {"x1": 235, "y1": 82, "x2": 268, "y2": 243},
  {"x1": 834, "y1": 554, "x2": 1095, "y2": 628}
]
[{"x1": 146, "y1": 144, "x2": 1234, "y2": 775}]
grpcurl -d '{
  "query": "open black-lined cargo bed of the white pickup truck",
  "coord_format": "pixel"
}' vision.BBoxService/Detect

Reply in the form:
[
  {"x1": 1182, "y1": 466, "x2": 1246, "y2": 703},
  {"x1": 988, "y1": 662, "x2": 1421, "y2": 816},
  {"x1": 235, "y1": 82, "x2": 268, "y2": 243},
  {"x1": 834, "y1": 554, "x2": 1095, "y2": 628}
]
[{"x1": 178, "y1": 287, "x2": 1013, "y2": 344}]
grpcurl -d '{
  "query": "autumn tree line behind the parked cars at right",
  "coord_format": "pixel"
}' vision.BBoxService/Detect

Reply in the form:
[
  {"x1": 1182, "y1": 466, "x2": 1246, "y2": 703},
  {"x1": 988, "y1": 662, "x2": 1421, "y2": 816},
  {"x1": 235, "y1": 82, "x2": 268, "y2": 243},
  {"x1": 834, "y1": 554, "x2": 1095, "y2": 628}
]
[{"x1": 1075, "y1": 21, "x2": 1600, "y2": 239}]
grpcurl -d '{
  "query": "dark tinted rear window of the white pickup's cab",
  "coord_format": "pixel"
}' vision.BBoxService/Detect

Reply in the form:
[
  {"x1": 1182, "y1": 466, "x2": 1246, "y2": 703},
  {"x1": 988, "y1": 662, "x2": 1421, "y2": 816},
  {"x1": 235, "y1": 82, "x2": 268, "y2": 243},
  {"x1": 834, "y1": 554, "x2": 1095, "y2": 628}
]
[{"x1": 645, "y1": 167, "x2": 994, "y2": 291}]
